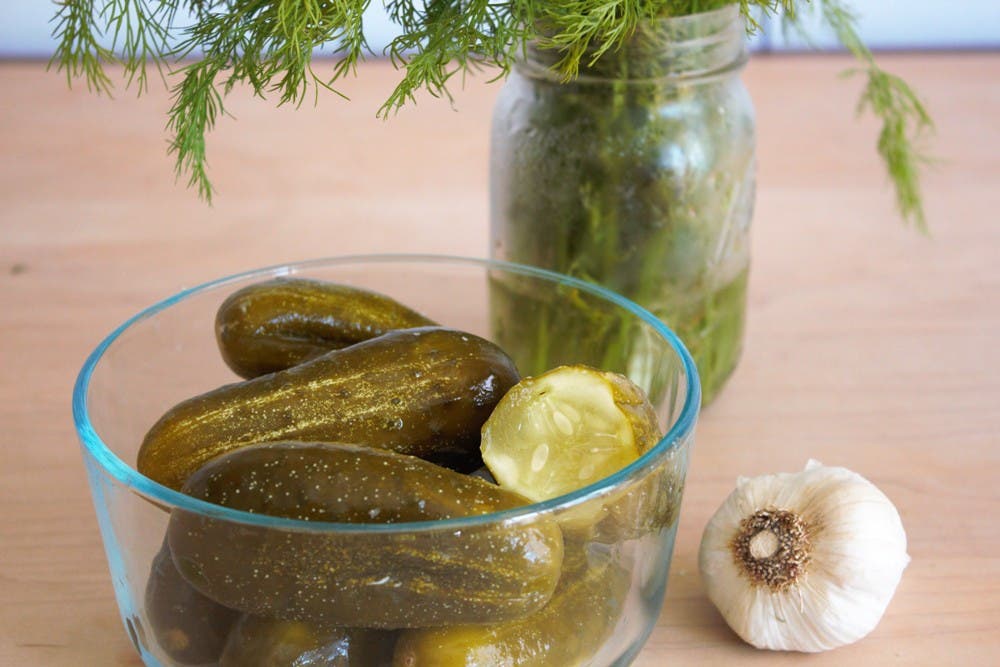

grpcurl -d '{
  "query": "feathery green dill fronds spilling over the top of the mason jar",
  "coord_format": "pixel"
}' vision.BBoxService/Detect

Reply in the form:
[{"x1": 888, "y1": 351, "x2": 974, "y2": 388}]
[{"x1": 50, "y1": 0, "x2": 932, "y2": 224}]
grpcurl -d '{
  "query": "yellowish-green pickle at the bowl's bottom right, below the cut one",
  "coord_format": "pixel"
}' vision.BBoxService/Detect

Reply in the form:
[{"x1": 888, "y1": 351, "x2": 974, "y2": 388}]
[{"x1": 392, "y1": 543, "x2": 629, "y2": 667}]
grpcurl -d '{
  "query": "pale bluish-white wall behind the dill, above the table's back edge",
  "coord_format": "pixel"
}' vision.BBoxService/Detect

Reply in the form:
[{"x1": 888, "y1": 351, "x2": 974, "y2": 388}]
[{"x1": 0, "y1": 0, "x2": 1000, "y2": 57}]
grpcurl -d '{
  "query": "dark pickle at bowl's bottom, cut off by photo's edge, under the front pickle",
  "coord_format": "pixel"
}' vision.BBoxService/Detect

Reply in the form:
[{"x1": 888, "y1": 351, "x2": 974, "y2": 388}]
[{"x1": 219, "y1": 616, "x2": 395, "y2": 667}]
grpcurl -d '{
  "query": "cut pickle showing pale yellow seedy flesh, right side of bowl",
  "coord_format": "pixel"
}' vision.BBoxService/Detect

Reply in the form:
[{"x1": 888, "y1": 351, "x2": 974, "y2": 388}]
[{"x1": 482, "y1": 364, "x2": 683, "y2": 543}]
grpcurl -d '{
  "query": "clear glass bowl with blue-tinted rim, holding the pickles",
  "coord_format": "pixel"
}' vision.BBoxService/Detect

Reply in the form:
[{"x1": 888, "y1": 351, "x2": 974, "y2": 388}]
[{"x1": 73, "y1": 256, "x2": 700, "y2": 667}]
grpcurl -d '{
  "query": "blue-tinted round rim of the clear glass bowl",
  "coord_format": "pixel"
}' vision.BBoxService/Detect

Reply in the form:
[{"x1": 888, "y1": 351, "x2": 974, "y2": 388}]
[{"x1": 72, "y1": 253, "x2": 701, "y2": 533}]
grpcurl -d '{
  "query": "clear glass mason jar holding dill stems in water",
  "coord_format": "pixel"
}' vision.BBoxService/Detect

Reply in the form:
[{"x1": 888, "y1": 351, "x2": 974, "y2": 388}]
[{"x1": 490, "y1": 5, "x2": 754, "y2": 403}]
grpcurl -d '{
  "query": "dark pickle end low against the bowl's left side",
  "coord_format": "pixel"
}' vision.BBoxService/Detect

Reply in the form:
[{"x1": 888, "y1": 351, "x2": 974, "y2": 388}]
[{"x1": 144, "y1": 542, "x2": 239, "y2": 665}]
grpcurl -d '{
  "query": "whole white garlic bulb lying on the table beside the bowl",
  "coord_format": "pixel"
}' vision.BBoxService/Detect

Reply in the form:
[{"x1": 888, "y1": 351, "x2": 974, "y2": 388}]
[{"x1": 698, "y1": 461, "x2": 910, "y2": 652}]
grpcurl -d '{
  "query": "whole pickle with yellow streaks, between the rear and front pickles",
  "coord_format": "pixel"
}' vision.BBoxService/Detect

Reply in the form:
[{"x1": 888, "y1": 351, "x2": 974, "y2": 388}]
[{"x1": 137, "y1": 327, "x2": 518, "y2": 489}]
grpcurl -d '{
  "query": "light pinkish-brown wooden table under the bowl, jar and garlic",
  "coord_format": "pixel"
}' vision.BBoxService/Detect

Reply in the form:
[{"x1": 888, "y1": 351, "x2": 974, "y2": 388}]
[{"x1": 0, "y1": 54, "x2": 1000, "y2": 667}]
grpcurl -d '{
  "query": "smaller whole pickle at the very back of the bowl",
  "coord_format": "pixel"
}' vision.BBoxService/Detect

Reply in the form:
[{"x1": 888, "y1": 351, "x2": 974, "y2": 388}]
[{"x1": 215, "y1": 278, "x2": 435, "y2": 378}]
